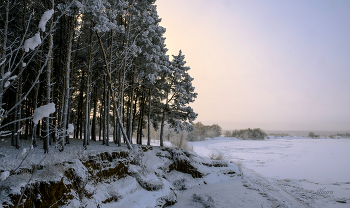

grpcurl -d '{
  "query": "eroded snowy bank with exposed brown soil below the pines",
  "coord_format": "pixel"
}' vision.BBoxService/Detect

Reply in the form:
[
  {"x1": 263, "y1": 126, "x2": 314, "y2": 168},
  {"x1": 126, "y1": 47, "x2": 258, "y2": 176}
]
[{"x1": 0, "y1": 139, "x2": 239, "y2": 207}]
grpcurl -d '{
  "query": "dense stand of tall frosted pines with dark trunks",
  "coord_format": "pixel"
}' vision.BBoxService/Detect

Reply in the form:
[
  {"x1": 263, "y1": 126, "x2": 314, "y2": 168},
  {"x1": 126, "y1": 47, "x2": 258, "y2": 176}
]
[{"x1": 0, "y1": 0, "x2": 197, "y2": 153}]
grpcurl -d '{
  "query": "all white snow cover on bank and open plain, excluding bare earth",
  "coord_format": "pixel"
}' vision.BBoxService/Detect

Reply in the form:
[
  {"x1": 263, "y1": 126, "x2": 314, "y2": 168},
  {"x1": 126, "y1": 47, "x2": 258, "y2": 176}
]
[{"x1": 0, "y1": 137, "x2": 350, "y2": 208}]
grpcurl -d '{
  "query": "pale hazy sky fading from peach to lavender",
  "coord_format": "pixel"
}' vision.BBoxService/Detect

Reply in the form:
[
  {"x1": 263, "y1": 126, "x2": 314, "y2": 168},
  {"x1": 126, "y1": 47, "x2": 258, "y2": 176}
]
[{"x1": 156, "y1": 0, "x2": 350, "y2": 131}]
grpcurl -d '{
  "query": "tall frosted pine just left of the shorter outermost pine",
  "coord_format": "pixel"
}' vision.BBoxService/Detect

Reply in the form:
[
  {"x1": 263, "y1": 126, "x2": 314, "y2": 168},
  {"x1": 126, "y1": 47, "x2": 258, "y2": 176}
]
[{"x1": 123, "y1": 1, "x2": 169, "y2": 144}]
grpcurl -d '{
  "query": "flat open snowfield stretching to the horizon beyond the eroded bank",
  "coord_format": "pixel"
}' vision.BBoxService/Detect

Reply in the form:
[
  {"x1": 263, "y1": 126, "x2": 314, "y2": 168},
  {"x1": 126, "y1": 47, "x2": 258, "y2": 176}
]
[{"x1": 189, "y1": 137, "x2": 350, "y2": 208}]
